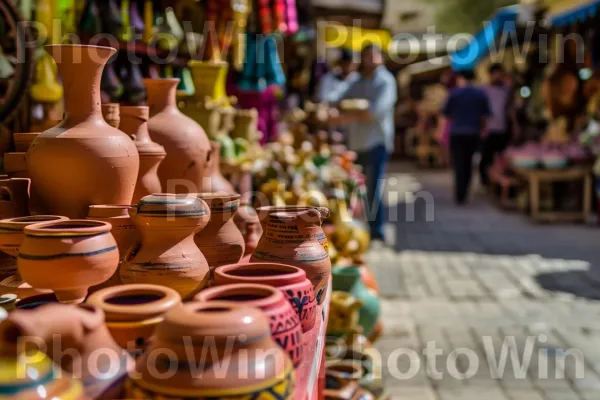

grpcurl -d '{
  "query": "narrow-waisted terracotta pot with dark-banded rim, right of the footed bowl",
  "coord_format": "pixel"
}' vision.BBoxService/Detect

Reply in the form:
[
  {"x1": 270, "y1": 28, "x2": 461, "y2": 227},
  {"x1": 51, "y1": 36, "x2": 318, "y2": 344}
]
[{"x1": 119, "y1": 194, "x2": 211, "y2": 298}]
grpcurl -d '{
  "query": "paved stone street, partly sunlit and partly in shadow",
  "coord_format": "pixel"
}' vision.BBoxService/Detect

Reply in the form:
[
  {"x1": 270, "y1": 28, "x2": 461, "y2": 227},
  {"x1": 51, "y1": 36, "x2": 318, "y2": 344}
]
[{"x1": 368, "y1": 165, "x2": 600, "y2": 400}]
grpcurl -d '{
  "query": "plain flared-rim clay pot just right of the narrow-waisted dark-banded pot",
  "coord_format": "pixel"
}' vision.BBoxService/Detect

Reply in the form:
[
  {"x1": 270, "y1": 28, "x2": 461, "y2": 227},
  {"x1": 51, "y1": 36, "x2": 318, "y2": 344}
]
[{"x1": 194, "y1": 193, "x2": 244, "y2": 272}]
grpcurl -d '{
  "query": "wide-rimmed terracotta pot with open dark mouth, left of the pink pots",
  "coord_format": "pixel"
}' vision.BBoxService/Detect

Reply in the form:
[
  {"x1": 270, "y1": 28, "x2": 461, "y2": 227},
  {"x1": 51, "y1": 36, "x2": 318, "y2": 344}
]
[{"x1": 87, "y1": 285, "x2": 181, "y2": 354}]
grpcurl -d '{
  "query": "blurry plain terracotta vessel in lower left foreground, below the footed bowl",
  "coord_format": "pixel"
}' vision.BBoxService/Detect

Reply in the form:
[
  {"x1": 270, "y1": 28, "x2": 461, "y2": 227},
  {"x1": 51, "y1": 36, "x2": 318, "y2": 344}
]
[{"x1": 2, "y1": 304, "x2": 134, "y2": 399}]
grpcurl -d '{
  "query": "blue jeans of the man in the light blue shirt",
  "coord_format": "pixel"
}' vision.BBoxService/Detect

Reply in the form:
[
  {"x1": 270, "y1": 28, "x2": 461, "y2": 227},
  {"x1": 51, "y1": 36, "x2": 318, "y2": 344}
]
[{"x1": 357, "y1": 145, "x2": 389, "y2": 240}]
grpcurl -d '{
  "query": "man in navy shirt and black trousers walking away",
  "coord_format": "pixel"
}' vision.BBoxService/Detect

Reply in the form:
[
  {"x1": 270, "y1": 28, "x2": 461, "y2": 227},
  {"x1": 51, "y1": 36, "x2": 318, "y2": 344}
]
[{"x1": 441, "y1": 71, "x2": 492, "y2": 205}]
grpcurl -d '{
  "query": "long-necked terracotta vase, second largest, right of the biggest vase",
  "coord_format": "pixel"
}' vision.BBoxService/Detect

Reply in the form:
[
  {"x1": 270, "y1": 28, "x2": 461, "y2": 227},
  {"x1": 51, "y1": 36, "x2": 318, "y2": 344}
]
[{"x1": 143, "y1": 79, "x2": 210, "y2": 193}]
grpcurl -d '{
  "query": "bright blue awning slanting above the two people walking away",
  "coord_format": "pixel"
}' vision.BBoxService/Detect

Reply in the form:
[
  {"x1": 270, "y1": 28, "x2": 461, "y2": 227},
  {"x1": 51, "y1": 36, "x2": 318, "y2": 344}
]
[{"x1": 451, "y1": 6, "x2": 519, "y2": 71}]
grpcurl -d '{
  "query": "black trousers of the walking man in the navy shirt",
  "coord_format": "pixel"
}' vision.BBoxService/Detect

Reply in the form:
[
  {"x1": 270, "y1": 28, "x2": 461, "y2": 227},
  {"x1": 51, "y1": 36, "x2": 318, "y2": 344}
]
[{"x1": 450, "y1": 133, "x2": 479, "y2": 204}]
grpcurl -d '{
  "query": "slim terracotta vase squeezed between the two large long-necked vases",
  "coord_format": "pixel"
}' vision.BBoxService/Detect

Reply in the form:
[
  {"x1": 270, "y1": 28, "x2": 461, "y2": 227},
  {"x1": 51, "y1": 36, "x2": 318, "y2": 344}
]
[{"x1": 120, "y1": 106, "x2": 167, "y2": 204}]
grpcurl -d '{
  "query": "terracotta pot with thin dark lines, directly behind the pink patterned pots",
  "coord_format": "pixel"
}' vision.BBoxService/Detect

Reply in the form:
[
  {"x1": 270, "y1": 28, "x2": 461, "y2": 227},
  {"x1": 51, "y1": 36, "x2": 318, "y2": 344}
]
[{"x1": 250, "y1": 207, "x2": 331, "y2": 304}]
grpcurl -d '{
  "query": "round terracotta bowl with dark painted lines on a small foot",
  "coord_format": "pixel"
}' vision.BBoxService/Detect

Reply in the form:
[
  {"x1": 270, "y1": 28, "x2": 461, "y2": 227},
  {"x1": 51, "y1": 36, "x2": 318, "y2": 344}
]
[{"x1": 17, "y1": 220, "x2": 119, "y2": 303}]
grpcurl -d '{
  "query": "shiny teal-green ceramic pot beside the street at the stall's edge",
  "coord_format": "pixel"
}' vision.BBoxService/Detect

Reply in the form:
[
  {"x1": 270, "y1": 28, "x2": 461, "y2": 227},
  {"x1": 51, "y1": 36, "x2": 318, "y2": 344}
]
[{"x1": 332, "y1": 266, "x2": 381, "y2": 336}]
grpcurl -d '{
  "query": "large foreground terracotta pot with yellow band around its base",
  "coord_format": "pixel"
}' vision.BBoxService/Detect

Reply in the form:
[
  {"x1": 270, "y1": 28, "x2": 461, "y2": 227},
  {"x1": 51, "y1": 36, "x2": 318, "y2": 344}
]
[{"x1": 125, "y1": 302, "x2": 295, "y2": 400}]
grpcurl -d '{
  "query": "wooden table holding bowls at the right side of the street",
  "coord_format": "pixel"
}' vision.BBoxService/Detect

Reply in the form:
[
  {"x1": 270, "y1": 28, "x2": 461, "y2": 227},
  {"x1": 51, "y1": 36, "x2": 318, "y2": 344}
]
[{"x1": 513, "y1": 166, "x2": 593, "y2": 222}]
